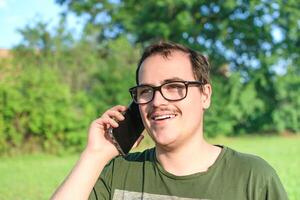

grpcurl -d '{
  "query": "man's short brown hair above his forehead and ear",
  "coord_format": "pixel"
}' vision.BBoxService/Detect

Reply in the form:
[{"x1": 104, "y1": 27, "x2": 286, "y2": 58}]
[{"x1": 135, "y1": 41, "x2": 210, "y2": 85}]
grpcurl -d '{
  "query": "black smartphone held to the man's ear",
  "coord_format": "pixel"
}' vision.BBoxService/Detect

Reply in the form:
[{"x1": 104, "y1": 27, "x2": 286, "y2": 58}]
[{"x1": 108, "y1": 102, "x2": 145, "y2": 156}]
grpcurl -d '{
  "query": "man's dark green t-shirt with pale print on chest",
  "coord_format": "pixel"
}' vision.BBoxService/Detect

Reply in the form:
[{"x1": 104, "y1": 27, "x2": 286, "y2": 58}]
[{"x1": 90, "y1": 146, "x2": 288, "y2": 200}]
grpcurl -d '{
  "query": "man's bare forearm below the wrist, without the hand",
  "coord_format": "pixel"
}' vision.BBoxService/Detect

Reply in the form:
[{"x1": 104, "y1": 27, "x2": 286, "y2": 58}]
[{"x1": 51, "y1": 150, "x2": 111, "y2": 200}]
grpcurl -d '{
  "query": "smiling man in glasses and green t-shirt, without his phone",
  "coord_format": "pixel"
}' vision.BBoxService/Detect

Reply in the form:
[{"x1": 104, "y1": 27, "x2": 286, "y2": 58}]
[{"x1": 53, "y1": 42, "x2": 287, "y2": 200}]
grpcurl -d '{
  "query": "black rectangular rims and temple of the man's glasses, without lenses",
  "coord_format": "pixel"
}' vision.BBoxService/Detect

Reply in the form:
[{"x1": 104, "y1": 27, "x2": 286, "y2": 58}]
[{"x1": 129, "y1": 80, "x2": 204, "y2": 105}]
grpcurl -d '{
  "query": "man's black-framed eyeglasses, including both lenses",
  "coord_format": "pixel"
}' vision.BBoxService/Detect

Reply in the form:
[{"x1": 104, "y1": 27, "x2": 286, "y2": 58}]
[{"x1": 129, "y1": 81, "x2": 203, "y2": 104}]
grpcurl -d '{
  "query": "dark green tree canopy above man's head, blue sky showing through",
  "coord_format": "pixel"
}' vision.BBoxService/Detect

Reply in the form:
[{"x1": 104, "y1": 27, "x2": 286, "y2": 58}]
[{"x1": 57, "y1": 0, "x2": 299, "y2": 67}]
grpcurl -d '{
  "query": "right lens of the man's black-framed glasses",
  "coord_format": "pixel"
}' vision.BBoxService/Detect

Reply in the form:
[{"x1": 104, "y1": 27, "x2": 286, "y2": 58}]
[{"x1": 161, "y1": 82, "x2": 186, "y2": 100}]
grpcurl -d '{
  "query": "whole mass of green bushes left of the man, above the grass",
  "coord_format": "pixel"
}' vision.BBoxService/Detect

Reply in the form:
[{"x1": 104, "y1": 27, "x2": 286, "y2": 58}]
[{"x1": 0, "y1": 20, "x2": 139, "y2": 154}]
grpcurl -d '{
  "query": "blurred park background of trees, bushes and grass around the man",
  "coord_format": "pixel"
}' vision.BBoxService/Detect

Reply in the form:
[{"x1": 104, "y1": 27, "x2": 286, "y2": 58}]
[{"x1": 0, "y1": 0, "x2": 300, "y2": 200}]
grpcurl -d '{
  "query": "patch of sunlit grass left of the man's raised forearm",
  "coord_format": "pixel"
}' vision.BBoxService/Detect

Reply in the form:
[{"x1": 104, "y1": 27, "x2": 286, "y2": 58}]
[{"x1": 0, "y1": 155, "x2": 78, "y2": 200}]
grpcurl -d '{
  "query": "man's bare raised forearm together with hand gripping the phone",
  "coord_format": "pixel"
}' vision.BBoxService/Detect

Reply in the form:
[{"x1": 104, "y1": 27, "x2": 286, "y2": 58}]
[{"x1": 51, "y1": 105, "x2": 126, "y2": 200}]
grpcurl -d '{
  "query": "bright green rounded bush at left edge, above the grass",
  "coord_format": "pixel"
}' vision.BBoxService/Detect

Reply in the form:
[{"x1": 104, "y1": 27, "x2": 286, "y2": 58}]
[{"x1": 0, "y1": 62, "x2": 85, "y2": 153}]
